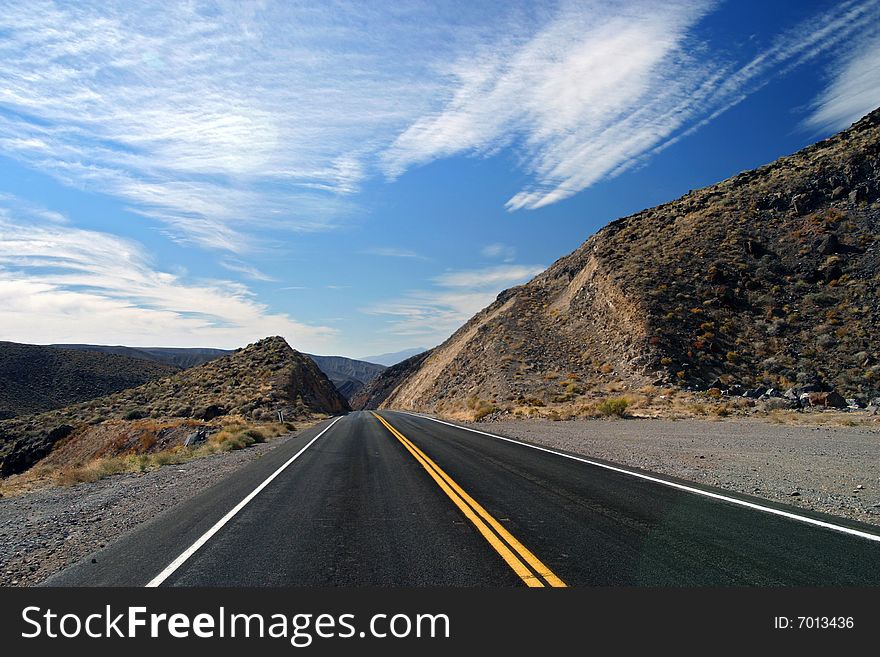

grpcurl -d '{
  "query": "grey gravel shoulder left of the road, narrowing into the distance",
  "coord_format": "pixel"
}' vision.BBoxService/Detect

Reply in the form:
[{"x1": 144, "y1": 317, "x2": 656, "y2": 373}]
[{"x1": 0, "y1": 434, "x2": 296, "y2": 586}]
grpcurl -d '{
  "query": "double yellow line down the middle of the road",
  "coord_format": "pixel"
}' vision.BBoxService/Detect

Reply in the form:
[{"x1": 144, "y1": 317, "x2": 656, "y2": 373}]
[{"x1": 373, "y1": 413, "x2": 565, "y2": 587}]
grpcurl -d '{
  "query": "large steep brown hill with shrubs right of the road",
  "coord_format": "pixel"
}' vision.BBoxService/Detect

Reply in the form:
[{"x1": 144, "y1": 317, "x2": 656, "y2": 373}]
[{"x1": 373, "y1": 110, "x2": 880, "y2": 417}]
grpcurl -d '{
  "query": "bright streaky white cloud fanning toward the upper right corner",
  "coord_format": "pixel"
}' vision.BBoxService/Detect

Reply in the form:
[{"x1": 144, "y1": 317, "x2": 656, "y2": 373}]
[{"x1": 384, "y1": 0, "x2": 880, "y2": 211}]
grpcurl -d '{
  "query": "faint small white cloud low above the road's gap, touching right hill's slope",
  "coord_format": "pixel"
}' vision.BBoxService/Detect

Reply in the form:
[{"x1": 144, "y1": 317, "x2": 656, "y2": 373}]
[{"x1": 363, "y1": 265, "x2": 544, "y2": 344}]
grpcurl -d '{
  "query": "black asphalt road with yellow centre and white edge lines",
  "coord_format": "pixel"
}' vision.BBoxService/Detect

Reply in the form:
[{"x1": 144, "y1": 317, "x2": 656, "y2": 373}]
[{"x1": 46, "y1": 411, "x2": 880, "y2": 587}]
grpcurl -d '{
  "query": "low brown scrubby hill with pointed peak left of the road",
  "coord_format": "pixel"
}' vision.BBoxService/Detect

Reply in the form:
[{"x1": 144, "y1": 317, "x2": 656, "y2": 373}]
[{"x1": 0, "y1": 337, "x2": 349, "y2": 476}]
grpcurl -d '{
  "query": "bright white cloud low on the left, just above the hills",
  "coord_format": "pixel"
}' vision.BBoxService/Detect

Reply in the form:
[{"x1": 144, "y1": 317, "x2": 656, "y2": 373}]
[{"x1": 0, "y1": 209, "x2": 335, "y2": 350}]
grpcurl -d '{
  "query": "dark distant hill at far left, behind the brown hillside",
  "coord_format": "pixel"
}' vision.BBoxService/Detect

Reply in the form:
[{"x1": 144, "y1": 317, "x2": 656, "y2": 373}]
[{"x1": 0, "y1": 342, "x2": 177, "y2": 419}]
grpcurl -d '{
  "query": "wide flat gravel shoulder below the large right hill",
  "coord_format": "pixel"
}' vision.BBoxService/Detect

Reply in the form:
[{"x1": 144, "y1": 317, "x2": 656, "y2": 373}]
[{"x1": 462, "y1": 419, "x2": 880, "y2": 525}]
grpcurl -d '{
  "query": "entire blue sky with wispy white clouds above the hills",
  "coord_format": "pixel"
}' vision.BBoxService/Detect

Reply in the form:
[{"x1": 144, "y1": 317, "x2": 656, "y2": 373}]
[{"x1": 0, "y1": 0, "x2": 880, "y2": 357}]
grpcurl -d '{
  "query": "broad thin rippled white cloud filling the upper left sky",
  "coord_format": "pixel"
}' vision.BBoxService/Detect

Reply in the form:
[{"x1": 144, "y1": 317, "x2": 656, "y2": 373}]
[{"x1": 0, "y1": 0, "x2": 467, "y2": 252}]
